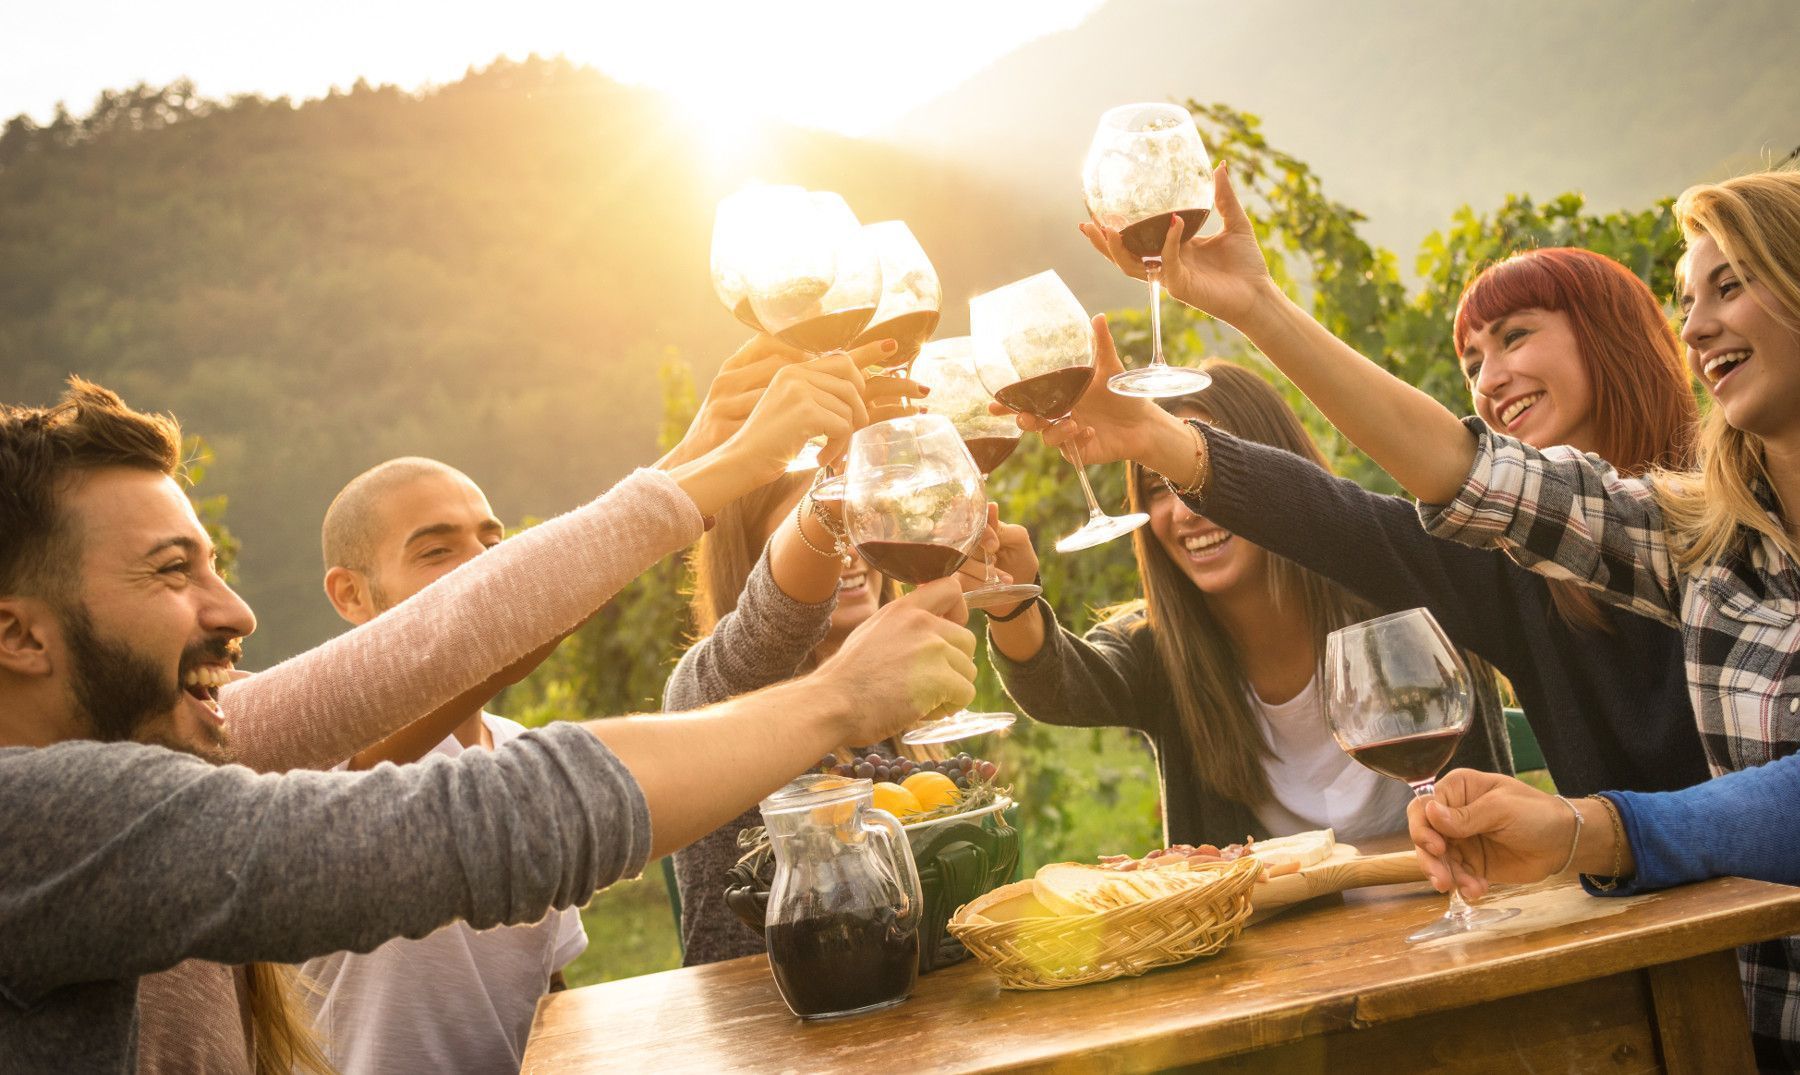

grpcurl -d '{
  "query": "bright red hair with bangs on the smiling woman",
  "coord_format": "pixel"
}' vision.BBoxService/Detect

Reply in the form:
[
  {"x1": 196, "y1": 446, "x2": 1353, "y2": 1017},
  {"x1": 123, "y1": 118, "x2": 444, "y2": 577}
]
[{"x1": 1454, "y1": 247, "x2": 1699, "y2": 475}]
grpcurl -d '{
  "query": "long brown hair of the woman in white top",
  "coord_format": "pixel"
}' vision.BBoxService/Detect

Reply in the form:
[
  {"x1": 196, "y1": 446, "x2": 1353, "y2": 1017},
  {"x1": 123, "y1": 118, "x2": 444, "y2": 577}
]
[{"x1": 1118, "y1": 358, "x2": 1373, "y2": 805}]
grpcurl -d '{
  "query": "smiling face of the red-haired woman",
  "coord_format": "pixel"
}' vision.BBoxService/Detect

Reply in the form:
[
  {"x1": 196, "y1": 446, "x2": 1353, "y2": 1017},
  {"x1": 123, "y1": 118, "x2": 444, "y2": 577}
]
[{"x1": 1460, "y1": 310, "x2": 1598, "y2": 452}]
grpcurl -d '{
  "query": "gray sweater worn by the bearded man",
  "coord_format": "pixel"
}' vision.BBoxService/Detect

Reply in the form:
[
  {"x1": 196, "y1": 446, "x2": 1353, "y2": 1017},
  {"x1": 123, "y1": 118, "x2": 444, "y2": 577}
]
[{"x1": 0, "y1": 726, "x2": 650, "y2": 1073}]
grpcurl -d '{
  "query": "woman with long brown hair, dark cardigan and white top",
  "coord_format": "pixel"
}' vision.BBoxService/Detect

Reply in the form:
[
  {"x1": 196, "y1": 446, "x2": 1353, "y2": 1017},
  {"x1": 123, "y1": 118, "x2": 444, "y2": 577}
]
[{"x1": 988, "y1": 360, "x2": 1512, "y2": 845}]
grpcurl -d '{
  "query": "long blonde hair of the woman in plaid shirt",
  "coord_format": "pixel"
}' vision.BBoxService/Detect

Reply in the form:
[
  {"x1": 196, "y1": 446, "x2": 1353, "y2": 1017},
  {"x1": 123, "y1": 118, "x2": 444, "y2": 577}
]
[{"x1": 1654, "y1": 169, "x2": 1800, "y2": 571}]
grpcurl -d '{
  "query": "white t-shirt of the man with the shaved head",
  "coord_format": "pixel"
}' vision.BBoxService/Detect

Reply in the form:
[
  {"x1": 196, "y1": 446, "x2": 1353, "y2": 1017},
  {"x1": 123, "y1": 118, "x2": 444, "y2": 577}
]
[{"x1": 301, "y1": 713, "x2": 587, "y2": 1075}]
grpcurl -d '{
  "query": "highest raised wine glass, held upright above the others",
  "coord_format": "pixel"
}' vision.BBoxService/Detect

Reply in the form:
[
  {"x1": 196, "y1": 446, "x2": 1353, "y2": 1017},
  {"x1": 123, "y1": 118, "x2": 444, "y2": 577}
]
[{"x1": 1082, "y1": 104, "x2": 1213, "y2": 398}]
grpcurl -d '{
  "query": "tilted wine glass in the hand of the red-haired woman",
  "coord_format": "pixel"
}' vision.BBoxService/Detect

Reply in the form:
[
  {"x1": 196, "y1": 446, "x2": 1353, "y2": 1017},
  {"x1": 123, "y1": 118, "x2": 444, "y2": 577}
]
[{"x1": 968, "y1": 270, "x2": 1150, "y2": 553}]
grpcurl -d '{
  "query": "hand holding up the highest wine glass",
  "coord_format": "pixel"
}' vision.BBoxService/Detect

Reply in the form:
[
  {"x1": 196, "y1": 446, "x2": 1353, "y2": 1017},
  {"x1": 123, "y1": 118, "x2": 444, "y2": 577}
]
[{"x1": 1080, "y1": 162, "x2": 1278, "y2": 328}]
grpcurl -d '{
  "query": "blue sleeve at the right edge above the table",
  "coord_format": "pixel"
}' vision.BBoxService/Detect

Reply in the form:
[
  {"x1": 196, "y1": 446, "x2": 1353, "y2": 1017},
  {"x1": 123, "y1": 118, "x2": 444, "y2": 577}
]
[{"x1": 1582, "y1": 754, "x2": 1800, "y2": 895}]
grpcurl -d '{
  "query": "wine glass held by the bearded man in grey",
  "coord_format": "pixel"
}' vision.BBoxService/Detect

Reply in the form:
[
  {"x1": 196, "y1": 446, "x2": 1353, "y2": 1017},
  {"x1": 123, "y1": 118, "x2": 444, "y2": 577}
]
[{"x1": 844, "y1": 414, "x2": 1013, "y2": 744}]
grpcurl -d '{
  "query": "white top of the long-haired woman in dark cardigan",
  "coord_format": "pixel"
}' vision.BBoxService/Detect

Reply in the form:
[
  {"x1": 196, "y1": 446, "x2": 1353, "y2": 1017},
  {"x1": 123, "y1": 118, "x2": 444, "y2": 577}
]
[{"x1": 1249, "y1": 675, "x2": 1413, "y2": 843}]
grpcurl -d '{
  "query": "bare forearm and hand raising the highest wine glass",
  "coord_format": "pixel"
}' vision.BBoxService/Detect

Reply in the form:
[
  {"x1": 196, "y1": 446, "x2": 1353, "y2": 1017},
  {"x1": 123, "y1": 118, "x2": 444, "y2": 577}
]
[{"x1": 1082, "y1": 164, "x2": 1474, "y2": 504}]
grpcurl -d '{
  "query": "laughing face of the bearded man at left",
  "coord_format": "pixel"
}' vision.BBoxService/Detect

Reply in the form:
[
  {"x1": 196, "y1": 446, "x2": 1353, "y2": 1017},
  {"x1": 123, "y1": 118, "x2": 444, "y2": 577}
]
[{"x1": 52, "y1": 468, "x2": 256, "y2": 760}]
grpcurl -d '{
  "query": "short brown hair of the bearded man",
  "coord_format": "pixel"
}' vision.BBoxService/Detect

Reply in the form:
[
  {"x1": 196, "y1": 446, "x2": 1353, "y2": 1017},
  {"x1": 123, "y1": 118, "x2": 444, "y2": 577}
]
[{"x1": 0, "y1": 376, "x2": 182, "y2": 598}]
